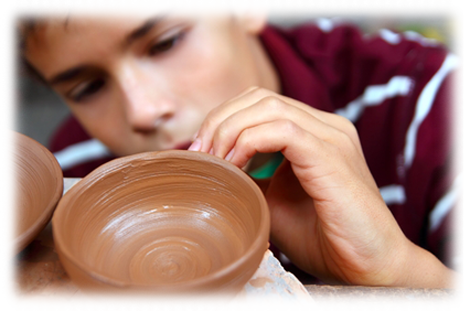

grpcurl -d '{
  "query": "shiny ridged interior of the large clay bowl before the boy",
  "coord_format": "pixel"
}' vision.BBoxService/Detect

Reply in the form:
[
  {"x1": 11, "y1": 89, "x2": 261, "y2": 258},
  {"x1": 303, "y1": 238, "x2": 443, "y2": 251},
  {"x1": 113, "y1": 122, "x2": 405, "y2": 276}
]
[{"x1": 53, "y1": 151, "x2": 267, "y2": 285}]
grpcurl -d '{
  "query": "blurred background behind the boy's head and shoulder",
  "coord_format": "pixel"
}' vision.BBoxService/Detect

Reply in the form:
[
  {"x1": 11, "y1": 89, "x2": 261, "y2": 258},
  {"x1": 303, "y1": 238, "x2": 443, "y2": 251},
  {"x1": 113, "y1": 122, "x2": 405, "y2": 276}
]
[{"x1": 0, "y1": 0, "x2": 464, "y2": 146}]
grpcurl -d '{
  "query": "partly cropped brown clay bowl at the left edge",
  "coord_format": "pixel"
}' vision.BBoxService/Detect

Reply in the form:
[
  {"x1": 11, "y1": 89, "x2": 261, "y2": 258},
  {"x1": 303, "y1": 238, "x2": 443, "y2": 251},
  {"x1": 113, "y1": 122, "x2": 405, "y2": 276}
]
[{"x1": 0, "y1": 128, "x2": 63, "y2": 264}]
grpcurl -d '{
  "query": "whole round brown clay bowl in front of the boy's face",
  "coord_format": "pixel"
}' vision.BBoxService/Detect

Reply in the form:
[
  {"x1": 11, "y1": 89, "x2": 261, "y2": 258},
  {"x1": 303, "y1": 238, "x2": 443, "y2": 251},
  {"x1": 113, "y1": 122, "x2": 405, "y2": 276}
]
[{"x1": 52, "y1": 150, "x2": 269, "y2": 310}]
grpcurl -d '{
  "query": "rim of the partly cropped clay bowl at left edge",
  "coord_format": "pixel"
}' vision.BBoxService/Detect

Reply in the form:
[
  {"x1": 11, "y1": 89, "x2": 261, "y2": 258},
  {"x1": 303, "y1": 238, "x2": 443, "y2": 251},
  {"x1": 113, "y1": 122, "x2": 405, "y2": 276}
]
[{"x1": 0, "y1": 127, "x2": 64, "y2": 262}]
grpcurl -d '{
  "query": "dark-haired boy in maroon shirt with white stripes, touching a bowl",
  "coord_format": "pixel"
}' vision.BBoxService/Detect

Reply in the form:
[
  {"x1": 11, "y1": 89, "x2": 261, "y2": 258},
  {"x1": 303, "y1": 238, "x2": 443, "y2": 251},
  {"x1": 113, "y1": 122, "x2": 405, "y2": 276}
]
[{"x1": 0, "y1": 0, "x2": 464, "y2": 288}]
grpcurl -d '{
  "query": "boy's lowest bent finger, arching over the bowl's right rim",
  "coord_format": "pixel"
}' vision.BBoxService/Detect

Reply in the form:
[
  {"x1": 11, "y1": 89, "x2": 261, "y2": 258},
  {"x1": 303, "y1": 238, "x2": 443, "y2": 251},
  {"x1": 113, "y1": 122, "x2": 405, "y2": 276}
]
[{"x1": 226, "y1": 119, "x2": 349, "y2": 201}]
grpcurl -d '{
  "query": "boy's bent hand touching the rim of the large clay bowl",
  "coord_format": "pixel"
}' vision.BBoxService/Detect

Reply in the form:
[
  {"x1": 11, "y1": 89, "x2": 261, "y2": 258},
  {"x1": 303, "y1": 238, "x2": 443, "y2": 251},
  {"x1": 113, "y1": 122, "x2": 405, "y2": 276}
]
[{"x1": 190, "y1": 88, "x2": 462, "y2": 286}]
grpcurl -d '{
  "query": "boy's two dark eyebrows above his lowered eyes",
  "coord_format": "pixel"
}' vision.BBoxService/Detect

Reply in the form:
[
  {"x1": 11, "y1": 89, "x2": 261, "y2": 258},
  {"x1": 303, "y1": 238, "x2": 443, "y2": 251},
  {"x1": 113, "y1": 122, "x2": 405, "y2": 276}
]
[{"x1": 48, "y1": 2, "x2": 183, "y2": 85}]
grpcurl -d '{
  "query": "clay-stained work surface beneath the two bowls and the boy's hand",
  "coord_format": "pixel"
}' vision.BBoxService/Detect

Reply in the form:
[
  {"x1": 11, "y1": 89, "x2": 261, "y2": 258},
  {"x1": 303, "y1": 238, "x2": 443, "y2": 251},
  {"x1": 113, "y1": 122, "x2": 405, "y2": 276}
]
[{"x1": 0, "y1": 179, "x2": 464, "y2": 311}]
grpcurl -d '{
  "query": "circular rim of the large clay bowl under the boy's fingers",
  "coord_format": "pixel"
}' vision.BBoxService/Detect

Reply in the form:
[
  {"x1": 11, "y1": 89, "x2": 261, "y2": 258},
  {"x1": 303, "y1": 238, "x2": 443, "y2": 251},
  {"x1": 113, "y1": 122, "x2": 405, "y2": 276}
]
[{"x1": 52, "y1": 150, "x2": 270, "y2": 294}]
